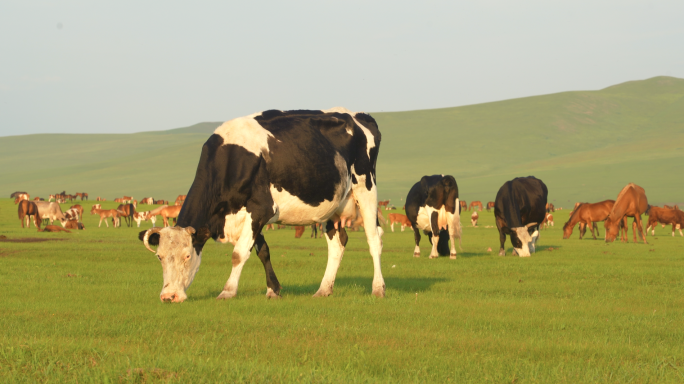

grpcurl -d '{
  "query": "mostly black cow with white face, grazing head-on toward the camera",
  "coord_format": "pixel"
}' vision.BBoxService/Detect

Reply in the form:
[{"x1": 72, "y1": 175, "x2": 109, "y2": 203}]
[{"x1": 494, "y1": 176, "x2": 549, "y2": 257}]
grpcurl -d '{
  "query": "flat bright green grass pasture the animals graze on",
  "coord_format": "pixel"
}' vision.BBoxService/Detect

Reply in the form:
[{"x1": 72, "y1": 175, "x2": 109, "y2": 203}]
[{"x1": 0, "y1": 199, "x2": 684, "y2": 383}]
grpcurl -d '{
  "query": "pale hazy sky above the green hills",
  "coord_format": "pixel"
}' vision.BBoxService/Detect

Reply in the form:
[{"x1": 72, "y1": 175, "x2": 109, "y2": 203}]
[{"x1": 0, "y1": 0, "x2": 684, "y2": 136}]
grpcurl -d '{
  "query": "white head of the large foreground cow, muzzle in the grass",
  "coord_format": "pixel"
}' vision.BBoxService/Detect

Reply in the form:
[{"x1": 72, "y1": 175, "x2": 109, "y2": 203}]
[{"x1": 138, "y1": 227, "x2": 211, "y2": 303}]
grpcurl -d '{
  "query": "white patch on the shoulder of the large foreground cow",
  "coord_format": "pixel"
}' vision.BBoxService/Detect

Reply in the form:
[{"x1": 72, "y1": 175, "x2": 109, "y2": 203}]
[{"x1": 214, "y1": 112, "x2": 274, "y2": 156}]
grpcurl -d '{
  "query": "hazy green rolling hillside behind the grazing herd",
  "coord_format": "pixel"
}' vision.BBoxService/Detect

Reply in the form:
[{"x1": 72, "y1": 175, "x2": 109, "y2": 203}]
[{"x1": 0, "y1": 77, "x2": 684, "y2": 206}]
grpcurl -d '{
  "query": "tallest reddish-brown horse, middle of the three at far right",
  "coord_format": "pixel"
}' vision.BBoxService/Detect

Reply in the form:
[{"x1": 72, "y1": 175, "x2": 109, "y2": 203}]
[{"x1": 603, "y1": 183, "x2": 648, "y2": 244}]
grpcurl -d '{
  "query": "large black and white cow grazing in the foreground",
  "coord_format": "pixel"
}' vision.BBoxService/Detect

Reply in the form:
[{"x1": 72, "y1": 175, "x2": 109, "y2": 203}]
[{"x1": 139, "y1": 108, "x2": 385, "y2": 302}]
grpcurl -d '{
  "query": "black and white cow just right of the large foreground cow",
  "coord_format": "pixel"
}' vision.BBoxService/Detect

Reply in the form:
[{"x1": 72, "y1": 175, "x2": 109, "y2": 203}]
[{"x1": 405, "y1": 175, "x2": 461, "y2": 259}]
